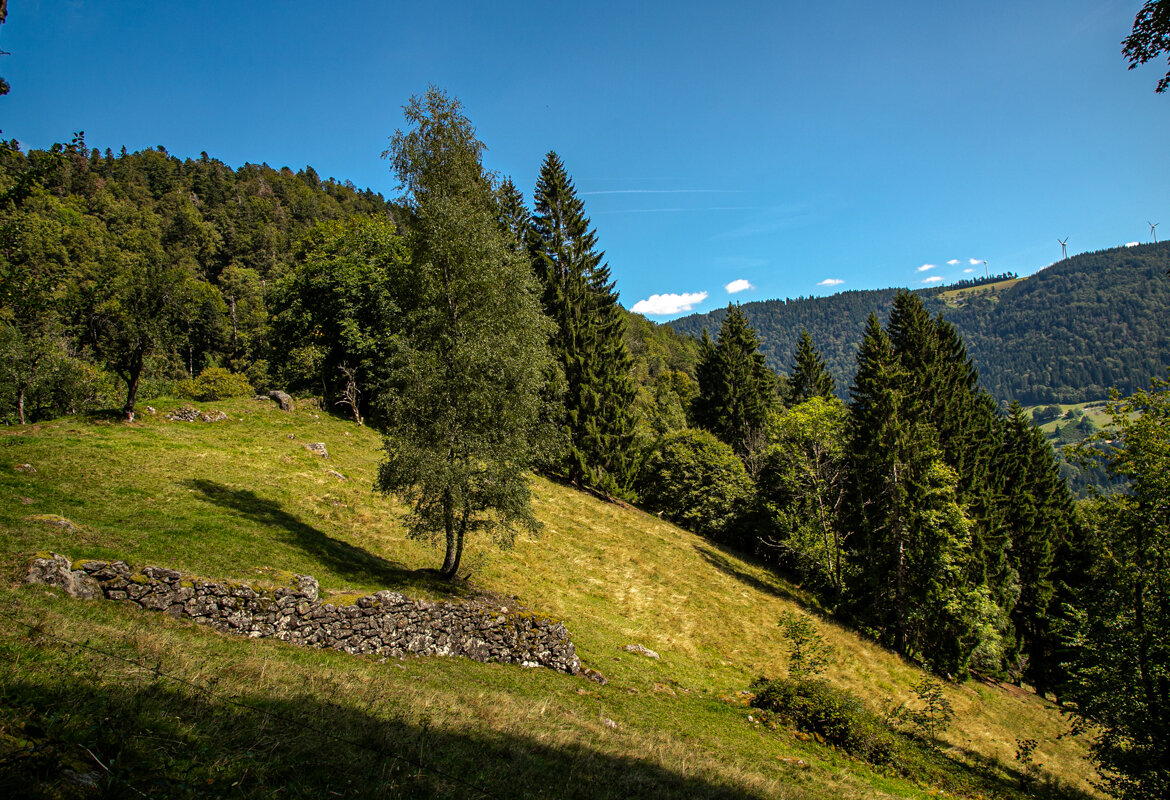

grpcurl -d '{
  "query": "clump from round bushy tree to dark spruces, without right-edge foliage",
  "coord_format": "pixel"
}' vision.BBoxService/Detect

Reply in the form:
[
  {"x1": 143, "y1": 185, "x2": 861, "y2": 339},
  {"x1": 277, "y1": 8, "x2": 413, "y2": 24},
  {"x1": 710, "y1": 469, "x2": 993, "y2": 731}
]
[{"x1": 644, "y1": 297, "x2": 1082, "y2": 690}]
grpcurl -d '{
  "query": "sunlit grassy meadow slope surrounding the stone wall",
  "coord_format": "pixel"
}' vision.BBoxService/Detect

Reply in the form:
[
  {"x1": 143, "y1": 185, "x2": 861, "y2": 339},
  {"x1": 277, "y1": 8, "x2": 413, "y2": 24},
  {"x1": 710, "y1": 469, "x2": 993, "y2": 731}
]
[{"x1": 0, "y1": 400, "x2": 1090, "y2": 798}]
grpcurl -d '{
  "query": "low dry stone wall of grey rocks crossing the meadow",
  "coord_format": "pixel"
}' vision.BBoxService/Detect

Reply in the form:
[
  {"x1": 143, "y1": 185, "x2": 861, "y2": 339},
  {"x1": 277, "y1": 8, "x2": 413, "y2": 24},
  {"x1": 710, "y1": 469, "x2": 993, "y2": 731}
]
[{"x1": 27, "y1": 553, "x2": 581, "y2": 675}]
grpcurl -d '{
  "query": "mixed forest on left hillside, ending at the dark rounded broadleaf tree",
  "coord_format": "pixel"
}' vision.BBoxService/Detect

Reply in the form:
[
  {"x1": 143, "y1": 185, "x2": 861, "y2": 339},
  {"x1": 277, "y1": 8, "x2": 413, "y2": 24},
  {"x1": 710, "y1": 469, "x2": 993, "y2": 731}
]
[{"x1": 0, "y1": 135, "x2": 390, "y2": 421}]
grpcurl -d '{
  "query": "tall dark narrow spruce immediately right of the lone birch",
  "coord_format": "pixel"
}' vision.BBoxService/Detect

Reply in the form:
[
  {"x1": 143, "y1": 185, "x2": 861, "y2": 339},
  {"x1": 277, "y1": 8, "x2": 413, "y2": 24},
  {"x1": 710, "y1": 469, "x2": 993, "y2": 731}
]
[{"x1": 529, "y1": 152, "x2": 638, "y2": 496}]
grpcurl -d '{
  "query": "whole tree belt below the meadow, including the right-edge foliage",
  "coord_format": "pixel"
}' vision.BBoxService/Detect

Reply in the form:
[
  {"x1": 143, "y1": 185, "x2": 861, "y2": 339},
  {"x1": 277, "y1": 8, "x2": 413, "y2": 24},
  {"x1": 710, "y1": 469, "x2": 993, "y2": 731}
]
[{"x1": 640, "y1": 304, "x2": 1170, "y2": 798}]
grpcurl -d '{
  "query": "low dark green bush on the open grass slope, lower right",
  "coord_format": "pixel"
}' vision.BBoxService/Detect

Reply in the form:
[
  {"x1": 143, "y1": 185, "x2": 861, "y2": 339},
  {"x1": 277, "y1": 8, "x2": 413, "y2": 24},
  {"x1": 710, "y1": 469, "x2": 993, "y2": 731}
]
[{"x1": 751, "y1": 678, "x2": 897, "y2": 765}]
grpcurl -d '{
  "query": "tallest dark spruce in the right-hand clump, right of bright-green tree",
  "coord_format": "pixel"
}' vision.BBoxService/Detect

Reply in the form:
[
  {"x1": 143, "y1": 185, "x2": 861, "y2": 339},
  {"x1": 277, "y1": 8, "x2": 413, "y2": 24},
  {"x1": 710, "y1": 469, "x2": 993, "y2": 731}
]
[{"x1": 848, "y1": 315, "x2": 990, "y2": 674}]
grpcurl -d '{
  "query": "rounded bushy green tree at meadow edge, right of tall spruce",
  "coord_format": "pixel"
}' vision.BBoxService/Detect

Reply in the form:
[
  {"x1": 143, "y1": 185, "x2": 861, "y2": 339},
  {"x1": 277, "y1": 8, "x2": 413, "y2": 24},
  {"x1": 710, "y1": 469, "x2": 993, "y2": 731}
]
[{"x1": 638, "y1": 429, "x2": 752, "y2": 540}]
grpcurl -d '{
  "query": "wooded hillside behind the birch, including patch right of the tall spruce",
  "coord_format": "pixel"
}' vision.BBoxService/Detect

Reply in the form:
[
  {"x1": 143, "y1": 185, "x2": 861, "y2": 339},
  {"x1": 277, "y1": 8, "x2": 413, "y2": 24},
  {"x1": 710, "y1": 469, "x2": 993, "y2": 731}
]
[{"x1": 0, "y1": 135, "x2": 697, "y2": 423}]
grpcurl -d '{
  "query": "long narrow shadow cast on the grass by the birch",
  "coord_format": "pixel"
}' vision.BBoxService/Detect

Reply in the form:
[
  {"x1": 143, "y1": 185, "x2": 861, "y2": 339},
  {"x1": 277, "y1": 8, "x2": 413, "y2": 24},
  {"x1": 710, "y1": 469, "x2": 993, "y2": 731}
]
[{"x1": 183, "y1": 478, "x2": 464, "y2": 595}]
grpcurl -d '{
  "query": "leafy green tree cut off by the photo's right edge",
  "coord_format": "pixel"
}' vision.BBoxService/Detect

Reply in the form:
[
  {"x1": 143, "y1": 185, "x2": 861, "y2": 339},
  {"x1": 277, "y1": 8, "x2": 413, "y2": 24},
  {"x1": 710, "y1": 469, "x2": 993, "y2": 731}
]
[{"x1": 1065, "y1": 379, "x2": 1170, "y2": 800}]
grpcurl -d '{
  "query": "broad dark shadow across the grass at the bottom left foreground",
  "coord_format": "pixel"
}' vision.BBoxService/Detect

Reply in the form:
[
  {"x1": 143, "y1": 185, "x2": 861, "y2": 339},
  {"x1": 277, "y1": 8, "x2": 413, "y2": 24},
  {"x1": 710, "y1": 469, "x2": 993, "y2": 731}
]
[{"x1": 0, "y1": 667, "x2": 776, "y2": 800}]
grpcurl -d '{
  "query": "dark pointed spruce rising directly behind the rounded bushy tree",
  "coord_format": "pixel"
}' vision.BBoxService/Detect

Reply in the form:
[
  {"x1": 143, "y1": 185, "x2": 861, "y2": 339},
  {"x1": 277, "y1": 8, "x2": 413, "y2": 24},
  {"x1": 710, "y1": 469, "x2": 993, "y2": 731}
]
[{"x1": 693, "y1": 304, "x2": 776, "y2": 471}]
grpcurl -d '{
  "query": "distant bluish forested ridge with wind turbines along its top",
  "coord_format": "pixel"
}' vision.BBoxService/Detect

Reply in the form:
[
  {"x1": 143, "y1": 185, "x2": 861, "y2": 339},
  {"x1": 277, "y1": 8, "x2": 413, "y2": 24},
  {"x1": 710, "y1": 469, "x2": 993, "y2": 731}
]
[{"x1": 669, "y1": 242, "x2": 1170, "y2": 405}]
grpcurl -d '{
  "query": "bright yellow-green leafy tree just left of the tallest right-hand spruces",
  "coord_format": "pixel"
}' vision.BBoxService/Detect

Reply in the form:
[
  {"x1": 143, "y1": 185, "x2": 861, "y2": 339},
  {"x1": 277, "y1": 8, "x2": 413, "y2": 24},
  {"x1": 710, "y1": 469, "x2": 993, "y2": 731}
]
[{"x1": 756, "y1": 395, "x2": 848, "y2": 594}]
